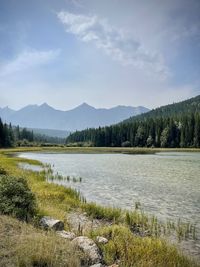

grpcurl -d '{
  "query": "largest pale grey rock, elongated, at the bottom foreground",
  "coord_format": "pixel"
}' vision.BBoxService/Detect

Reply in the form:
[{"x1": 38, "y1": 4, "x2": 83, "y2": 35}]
[{"x1": 72, "y1": 236, "x2": 101, "y2": 264}]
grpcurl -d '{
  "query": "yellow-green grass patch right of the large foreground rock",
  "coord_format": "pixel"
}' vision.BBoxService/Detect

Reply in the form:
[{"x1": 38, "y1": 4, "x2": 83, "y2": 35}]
[{"x1": 91, "y1": 225, "x2": 197, "y2": 267}]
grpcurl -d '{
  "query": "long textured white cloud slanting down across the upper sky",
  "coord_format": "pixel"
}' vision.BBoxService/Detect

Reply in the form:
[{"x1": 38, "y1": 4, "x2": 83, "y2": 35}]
[{"x1": 57, "y1": 11, "x2": 169, "y2": 79}]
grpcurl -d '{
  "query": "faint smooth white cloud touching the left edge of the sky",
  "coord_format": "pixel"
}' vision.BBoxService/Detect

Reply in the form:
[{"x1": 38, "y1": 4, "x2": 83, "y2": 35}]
[{"x1": 0, "y1": 50, "x2": 60, "y2": 76}]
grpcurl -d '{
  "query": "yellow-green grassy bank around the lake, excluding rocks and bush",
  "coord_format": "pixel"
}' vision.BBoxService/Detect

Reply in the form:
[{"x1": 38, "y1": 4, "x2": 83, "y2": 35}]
[{"x1": 0, "y1": 148, "x2": 198, "y2": 267}]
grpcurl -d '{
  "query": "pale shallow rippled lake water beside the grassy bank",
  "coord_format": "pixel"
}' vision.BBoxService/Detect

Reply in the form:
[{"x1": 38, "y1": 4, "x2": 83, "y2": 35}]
[{"x1": 20, "y1": 152, "x2": 200, "y2": 254}]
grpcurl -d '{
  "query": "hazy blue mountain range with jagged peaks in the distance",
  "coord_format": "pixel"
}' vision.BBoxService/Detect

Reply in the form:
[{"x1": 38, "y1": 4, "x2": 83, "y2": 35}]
[{"x1": 0, "y1": 103, "x2": 149, "y2": 131}]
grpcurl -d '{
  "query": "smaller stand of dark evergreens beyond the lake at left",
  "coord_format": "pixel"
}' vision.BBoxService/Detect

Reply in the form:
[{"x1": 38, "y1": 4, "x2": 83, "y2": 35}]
[{"x1": 0, "y1": 118, "x2": 64, "y2": 148}]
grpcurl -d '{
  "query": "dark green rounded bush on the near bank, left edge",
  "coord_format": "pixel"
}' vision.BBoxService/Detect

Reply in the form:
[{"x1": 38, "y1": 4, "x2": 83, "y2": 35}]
[{"x1": 0, "y1": 175, "x2": 36, "y2": 221}]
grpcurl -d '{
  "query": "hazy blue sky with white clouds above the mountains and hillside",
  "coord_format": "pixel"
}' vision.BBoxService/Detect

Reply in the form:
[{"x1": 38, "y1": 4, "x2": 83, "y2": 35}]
[{"x1": 0, "y1": 0, "x2": 200, "y2": 110}]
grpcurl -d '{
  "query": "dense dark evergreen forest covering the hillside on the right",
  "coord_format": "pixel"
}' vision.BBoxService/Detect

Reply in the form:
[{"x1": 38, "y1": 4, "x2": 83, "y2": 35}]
[{"x1": 66, "y1": 96, "x2": 200, "y2": 148}]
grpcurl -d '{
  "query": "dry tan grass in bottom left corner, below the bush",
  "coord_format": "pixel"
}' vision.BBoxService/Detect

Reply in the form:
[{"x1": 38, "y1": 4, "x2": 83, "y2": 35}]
[{"x1": 0, "y1": 216, "x2": 84, "y2": 267}]
